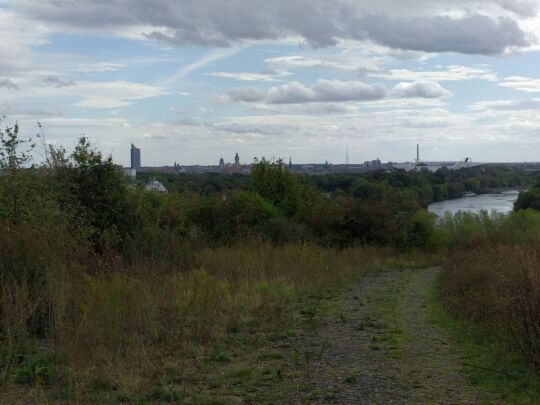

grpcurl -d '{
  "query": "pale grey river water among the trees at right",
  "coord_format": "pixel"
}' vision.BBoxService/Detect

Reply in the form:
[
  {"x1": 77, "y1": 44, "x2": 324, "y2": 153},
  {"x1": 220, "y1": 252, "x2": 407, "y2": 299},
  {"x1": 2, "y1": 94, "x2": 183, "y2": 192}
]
[{"x1": 428, "y1": 190, "x2": 519, "y2": 217}]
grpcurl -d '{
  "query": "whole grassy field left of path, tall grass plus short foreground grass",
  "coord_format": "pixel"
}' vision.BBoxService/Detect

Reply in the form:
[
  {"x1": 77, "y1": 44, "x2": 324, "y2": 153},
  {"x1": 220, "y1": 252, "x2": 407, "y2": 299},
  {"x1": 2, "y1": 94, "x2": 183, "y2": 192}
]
[{"x1": 2, "y1": 241, "x2": 434, "y2": 403}]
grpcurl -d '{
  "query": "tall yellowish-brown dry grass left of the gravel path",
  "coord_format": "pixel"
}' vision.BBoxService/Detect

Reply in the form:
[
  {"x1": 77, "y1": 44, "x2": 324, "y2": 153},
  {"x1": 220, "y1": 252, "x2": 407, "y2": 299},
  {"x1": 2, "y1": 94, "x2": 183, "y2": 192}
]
[{"x1": 0, "y1": 232, "x2": 410, "y2": 392}]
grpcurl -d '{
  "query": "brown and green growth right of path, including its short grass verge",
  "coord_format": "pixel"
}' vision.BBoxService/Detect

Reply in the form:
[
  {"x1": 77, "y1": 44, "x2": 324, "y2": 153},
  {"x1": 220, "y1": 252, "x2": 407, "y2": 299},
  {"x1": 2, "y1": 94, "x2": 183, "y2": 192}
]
[{"x1": 439, "y1": 210, "x2": 540, "y2": 396}]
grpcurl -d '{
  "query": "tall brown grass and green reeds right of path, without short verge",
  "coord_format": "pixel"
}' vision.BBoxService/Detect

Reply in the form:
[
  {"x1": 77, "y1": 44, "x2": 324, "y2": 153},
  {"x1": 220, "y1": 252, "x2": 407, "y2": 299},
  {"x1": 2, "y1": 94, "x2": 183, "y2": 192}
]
[{"x1": 440, "y1": 211, "x2": 540, "y2": 371}]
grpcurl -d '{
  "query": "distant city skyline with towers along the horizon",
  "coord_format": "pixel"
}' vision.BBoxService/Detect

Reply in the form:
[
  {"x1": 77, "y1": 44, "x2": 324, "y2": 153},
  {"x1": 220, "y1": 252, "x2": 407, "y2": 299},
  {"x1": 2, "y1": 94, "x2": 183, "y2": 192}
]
[{"x1": 124, "y1": 144, "x2": 540, "y2": 177}]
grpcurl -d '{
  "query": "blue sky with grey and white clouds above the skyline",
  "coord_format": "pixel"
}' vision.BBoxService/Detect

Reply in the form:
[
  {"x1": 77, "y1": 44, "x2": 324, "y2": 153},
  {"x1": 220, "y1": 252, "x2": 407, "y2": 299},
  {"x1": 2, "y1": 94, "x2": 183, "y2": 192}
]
[{"x1": 0, "y1": 0, "x2": 540, "y2": 165}]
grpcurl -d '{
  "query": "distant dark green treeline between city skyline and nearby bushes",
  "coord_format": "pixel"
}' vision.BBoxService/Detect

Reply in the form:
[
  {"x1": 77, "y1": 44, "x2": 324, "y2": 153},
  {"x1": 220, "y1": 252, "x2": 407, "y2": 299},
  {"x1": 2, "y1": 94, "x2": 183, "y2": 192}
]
[{"x1": 138, "y1": 166, "x2": 533, "y2": 208}]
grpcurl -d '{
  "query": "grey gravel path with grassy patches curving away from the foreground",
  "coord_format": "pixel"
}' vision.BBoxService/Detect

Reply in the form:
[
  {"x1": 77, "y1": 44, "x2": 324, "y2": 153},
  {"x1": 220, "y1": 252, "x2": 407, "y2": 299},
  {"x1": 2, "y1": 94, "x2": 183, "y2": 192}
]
[{"x1": 298, "y1": 269, "x2": 486, "y2": 404}]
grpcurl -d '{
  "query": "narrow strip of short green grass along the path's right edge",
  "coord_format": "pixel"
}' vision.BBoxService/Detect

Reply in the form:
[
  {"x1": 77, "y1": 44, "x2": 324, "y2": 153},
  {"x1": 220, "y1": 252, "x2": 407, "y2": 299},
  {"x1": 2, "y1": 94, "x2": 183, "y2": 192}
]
[{"x1": 426, "y1": 280, "x2": 540, "y2": 404}]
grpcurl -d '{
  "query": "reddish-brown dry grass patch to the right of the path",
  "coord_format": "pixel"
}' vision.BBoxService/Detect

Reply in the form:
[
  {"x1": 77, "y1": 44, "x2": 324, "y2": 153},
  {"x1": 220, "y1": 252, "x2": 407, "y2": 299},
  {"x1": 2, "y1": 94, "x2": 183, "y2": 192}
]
[{"x1": 441, "y1": 245, "x2": 540, "y2": 371}]
